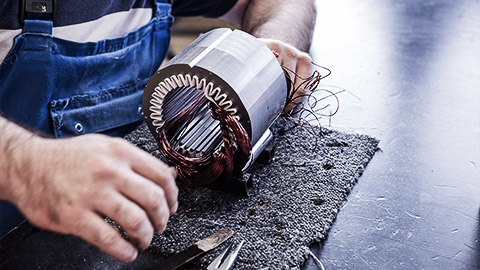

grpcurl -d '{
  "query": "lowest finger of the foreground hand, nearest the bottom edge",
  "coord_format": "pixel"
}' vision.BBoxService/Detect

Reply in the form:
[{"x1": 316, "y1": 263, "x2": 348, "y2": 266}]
[{"x1": 73, "y1": 212, "x2": 138, "y2": 262}]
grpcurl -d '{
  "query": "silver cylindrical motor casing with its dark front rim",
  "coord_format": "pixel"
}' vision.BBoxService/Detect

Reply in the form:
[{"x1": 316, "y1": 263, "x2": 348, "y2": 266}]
[{"x1": 143, "y1": 28, "x2": 287, "y2": 171}]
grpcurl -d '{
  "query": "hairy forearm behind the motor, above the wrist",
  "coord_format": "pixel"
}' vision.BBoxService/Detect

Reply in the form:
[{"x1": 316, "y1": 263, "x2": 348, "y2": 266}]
[{"x1": 242, "y1": 0, "x2": 316, "y2": 51}]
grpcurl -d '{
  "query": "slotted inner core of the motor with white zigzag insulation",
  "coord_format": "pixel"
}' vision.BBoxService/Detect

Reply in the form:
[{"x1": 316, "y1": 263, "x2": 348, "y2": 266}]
[{"x1": 150, "y1": 74, "x2": 239, "y2": 157}]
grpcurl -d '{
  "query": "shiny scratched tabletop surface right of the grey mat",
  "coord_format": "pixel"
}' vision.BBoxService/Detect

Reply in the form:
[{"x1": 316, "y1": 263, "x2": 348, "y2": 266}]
[{"x1": 305, "y1": 0, "x2": 480, "y2": 269}]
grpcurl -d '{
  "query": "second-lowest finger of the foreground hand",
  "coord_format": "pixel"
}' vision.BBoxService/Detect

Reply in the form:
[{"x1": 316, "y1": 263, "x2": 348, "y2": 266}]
[{"x1": 93, "y1": 191, "x2": 154, "y2": 250}]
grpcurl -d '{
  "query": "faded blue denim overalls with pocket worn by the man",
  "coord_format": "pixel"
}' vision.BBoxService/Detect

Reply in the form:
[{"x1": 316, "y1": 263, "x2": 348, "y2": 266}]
[{"x1": 0, "y1": 0, "x2": 173, "y2": 237}]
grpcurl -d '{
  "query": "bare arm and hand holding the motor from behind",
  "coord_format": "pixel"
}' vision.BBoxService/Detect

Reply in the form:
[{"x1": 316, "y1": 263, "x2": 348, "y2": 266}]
[{"x1": 221, "y1": 0, "x2": 316, "y2": 112}]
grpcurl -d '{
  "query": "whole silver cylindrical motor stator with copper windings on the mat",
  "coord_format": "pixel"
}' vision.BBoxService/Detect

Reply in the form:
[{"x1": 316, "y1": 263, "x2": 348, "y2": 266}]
[{"x1": 143, "y1": 29, "x2": 287, "y2": 188}]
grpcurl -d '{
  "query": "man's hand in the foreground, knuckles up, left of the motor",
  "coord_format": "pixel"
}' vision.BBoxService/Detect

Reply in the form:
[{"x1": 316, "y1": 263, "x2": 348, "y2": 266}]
[{"x1": 0, "y1": 118, "x2": 178, "y2": 262}]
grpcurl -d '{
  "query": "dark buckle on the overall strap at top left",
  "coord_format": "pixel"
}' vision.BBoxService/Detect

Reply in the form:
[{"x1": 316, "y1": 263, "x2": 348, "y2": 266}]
[{"x1": 20, "y1": 0, "x2": 55, "y2": 23}]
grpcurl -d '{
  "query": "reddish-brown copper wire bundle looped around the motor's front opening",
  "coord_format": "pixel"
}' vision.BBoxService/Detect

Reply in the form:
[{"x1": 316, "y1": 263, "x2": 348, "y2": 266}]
[{"x1": 158, "y1": 87, "x2": 252, "y2": 186}]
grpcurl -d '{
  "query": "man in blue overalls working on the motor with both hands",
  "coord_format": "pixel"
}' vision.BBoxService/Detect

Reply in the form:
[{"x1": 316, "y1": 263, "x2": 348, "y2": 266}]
[{"x1": 0, "y1": 0, "x2": 315, "y2": 262}]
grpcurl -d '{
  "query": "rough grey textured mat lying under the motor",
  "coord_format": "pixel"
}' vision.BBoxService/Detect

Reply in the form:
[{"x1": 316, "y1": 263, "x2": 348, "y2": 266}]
[{"x1": 126, "y1": 124, "x2": 378, "y2": 269}]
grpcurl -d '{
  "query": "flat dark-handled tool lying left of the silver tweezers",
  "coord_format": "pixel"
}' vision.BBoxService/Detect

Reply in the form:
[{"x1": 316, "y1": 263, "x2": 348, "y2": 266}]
[{"x1": 160, "y1": 228, "x2": 233, "y2": 270}]
